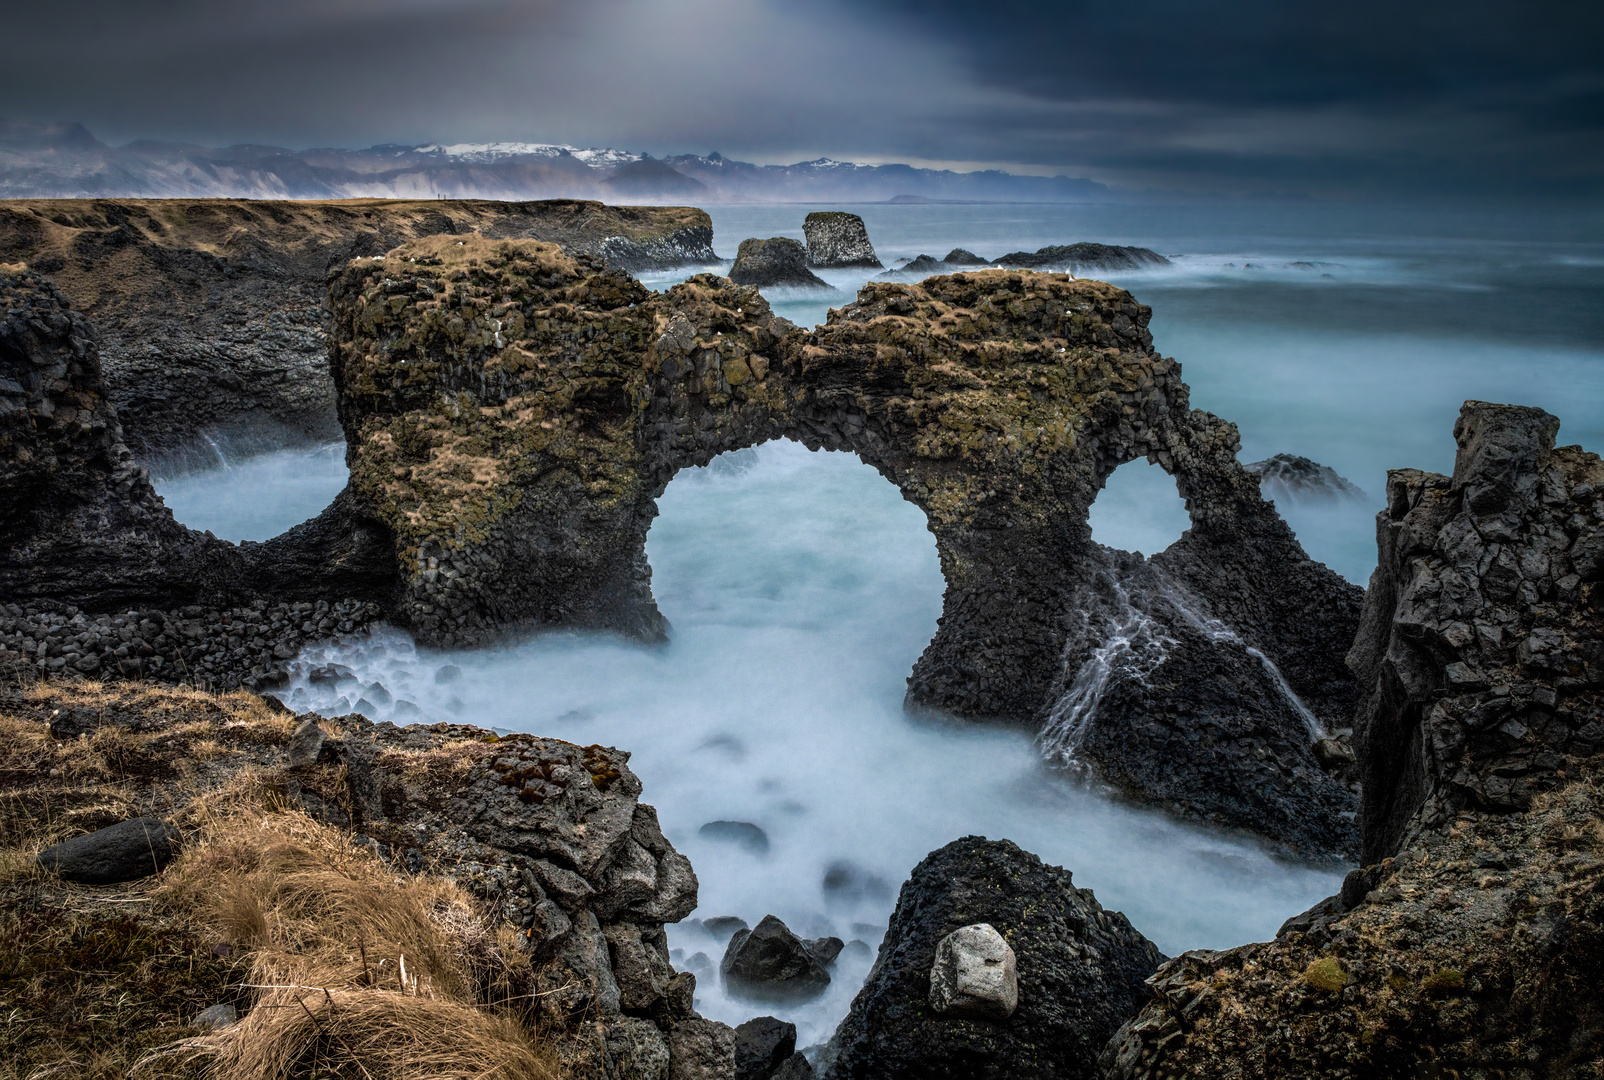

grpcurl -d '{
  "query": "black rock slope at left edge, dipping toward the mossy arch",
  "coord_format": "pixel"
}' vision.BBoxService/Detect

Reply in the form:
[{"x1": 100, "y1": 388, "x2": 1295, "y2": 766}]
[{"x1": 0, "y1": 271, "x2": 395, "y2": 688}]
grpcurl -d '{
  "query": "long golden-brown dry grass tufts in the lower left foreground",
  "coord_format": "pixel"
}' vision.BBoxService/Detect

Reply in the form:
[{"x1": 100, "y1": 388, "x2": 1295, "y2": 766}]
[{"x1": 144, "y1": 799, "x2": 555, "y2": 1080}]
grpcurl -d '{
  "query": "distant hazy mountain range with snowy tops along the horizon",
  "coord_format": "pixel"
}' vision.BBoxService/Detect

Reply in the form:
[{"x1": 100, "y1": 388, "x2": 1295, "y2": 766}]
[{"x1": 0, "y1": 120, "x2": 1118, "y2": 204}]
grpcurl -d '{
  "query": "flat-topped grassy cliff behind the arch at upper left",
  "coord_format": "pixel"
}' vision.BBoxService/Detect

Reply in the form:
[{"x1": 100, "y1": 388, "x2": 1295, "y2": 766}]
[{"x1": 0, "y1": 199, "x2": 717, "y2": 462}]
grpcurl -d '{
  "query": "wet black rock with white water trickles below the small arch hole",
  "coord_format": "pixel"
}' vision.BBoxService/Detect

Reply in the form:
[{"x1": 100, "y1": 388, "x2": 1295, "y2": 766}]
[{"x1": 1039, "y1": 549, "x2": 1359, "y2": 862}]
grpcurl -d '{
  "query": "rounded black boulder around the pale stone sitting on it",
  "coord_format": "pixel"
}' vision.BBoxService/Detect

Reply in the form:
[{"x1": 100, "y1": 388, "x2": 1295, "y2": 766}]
[{"x1": 824, "y1": 836, "x2": 1163, "y2": 1080}]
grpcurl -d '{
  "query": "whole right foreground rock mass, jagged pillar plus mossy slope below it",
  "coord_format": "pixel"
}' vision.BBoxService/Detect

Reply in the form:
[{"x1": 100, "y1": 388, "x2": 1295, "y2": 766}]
[{"x1": 1100, "y1": 401, "x2": 1604, "y2": 1080}]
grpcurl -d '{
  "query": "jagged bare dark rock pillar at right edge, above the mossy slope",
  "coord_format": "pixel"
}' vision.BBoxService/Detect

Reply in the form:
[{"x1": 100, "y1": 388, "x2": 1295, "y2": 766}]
[{"x1": 1349, "y1": 401, "x2": 1604, "y2": 863}]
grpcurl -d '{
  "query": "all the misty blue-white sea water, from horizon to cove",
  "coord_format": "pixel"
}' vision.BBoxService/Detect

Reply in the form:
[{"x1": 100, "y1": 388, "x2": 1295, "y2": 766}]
[{"x1": 159, "y1": 205, "x2": 1604, "y2": 1045}]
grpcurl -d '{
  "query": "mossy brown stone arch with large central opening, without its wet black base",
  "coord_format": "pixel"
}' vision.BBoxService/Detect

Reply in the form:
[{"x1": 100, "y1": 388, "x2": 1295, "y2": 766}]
[{"x1": 319, "y1": 238, "x2": 1360, "y2": 731}]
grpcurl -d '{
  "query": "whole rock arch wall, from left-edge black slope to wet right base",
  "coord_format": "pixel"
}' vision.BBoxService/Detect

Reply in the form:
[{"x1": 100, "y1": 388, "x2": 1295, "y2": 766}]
[{"x1": 0, "y1": 236, "x2": 1362, "y2": 854}]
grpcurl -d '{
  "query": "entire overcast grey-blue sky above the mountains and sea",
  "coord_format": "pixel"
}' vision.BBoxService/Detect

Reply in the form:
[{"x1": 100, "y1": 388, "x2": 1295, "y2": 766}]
[{"x1": 0, "y1": 0, "x2": 1604, "y2": 199}]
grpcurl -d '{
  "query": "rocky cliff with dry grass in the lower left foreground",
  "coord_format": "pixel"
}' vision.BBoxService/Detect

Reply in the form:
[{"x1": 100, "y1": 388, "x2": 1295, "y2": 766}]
[{"x1": 0, "y1": 685, "x2": 733, "y2": 1080}]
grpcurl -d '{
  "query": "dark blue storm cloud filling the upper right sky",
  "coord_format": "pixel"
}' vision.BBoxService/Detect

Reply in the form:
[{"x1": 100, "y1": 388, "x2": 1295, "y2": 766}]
[{"x1": 868, "y1": 0, "x2": 1604, "y2": 194}]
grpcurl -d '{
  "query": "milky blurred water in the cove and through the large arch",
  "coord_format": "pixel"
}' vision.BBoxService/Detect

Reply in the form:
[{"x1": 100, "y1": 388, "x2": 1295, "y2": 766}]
[{"x1": 272, "y1": 443, "x2": 1341, "y2": 1043}]
